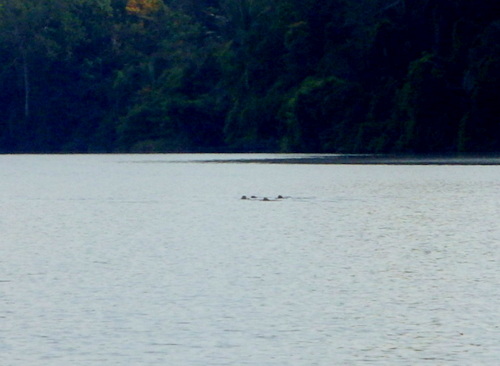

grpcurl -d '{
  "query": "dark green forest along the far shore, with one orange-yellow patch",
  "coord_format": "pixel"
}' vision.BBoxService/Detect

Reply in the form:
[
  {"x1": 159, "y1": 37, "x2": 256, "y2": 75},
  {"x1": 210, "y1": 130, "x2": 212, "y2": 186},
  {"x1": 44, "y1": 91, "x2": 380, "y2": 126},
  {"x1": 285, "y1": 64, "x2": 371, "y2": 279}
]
[{"x1": 0, "y1": 0, "x2": 500, "y2": 153}]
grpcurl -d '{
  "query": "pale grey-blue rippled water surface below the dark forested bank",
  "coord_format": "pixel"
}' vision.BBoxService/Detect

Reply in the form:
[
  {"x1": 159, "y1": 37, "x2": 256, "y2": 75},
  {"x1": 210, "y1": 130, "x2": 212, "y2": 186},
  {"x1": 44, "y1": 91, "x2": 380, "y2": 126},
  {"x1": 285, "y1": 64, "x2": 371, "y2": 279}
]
[{"x1": 0, "y1": 155, "x2": 500, "y2": 366}]
